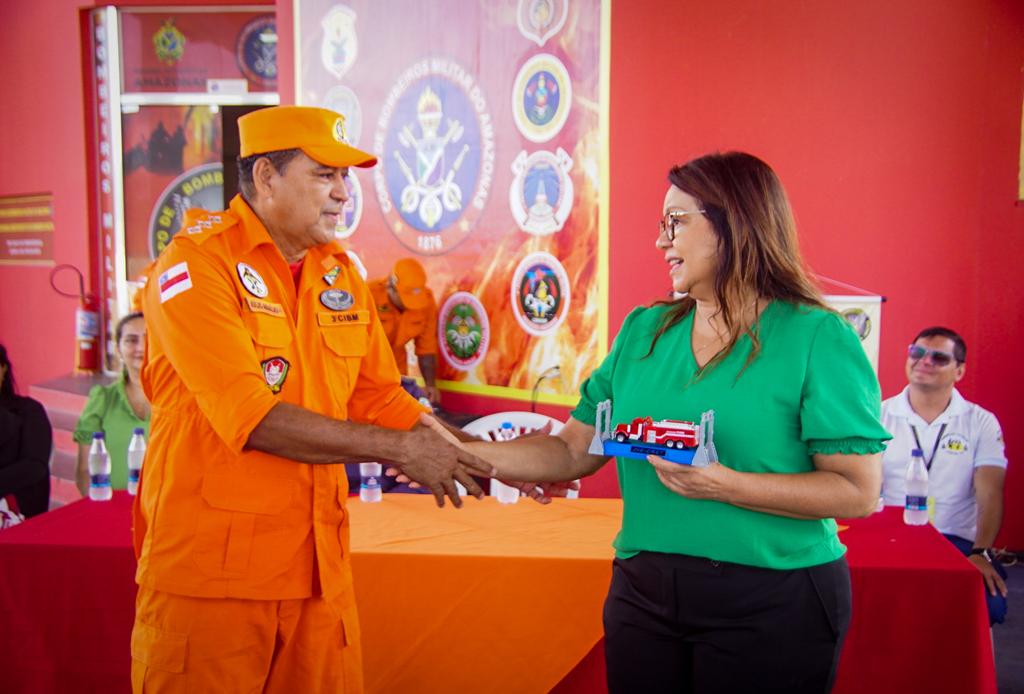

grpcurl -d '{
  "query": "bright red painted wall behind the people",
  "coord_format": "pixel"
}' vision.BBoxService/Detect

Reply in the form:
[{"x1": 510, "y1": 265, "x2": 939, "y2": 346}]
[{"x1": 0, "y1": 0, "x2": 1024, "y2": 548}]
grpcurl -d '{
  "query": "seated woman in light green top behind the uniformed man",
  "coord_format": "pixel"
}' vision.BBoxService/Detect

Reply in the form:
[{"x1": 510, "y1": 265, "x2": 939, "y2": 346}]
[{"x1": 75, "y1": 313, "x2": 150, "y2": 496}]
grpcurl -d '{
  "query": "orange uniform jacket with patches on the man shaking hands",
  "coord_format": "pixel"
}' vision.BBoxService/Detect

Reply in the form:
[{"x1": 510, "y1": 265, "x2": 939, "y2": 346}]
[{"x1": 133, "y1": 197, "x2": 423, "y2": 628}]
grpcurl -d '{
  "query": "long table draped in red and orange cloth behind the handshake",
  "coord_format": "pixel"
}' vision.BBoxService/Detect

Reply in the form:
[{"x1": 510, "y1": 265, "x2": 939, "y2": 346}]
[{"x1": 0, "y1": 493, "x2": 995, "y2": 694}]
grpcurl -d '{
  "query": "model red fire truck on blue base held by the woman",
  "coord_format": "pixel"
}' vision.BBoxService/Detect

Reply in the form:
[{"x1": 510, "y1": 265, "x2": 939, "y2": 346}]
[{"x1": 590, "y1": 400, "x2": 718, "y2": 466}]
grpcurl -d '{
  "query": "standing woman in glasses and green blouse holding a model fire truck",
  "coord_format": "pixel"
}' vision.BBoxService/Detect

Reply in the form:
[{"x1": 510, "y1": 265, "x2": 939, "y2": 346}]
[{"x1": 444, "y1": 153, "x2": 890, "y2": 694}]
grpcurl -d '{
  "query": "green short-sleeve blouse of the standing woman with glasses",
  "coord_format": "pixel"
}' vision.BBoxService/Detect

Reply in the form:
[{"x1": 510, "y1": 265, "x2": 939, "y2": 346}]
[{"x1": 572, "y1": 301, "x2": 890, "y2": 569}]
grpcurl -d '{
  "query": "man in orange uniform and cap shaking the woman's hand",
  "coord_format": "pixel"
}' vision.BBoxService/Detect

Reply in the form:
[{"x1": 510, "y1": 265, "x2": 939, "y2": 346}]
[{"x1": 131, "y1": 106, "x2": 490, "y2": 693}]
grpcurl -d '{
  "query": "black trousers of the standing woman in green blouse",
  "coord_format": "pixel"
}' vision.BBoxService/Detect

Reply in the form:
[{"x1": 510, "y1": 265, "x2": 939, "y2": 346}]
[{"x1": 604, "y1": 552, "x2": 850, "y2": 694}]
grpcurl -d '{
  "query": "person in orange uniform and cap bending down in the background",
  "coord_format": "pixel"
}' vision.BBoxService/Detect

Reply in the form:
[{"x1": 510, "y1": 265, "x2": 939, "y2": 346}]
[{"x1": 369, "y1": 258, "x2": 440, "y2": 402}]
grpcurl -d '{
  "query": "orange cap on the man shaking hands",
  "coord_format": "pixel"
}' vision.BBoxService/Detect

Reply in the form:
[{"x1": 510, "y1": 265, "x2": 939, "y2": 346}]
[{"x1": 239, "y1": 106, "x2": 377, "y2": 167}]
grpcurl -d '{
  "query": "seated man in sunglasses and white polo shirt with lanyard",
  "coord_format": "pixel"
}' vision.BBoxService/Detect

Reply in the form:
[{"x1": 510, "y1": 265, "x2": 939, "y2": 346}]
[{"x1": 882, "y1": 328, "x2": 1007, "y2": 623}]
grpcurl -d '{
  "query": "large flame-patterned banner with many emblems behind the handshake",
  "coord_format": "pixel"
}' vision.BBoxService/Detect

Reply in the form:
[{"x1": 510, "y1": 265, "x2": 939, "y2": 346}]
[{"x1": 295, "y1": 0, "x2": 607, "y2": 403}]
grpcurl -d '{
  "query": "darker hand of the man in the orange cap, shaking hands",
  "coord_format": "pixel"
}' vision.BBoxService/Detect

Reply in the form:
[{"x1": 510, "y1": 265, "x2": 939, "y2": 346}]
[{"x1": 393, "y1": 415, "x2": 495, "y2": 508}]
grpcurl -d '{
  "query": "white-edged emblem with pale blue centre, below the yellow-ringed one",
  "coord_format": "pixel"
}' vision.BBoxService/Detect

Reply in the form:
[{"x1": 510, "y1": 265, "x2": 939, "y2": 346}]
[{"x1": 509, "y1": 147, "x2": 572, "y2": 236}]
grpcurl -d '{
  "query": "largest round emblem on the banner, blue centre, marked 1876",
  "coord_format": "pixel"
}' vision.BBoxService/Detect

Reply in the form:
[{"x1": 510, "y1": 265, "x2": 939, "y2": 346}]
[{"x1": 374, "y1": 58, "x2": 495, "y2": 255}]
